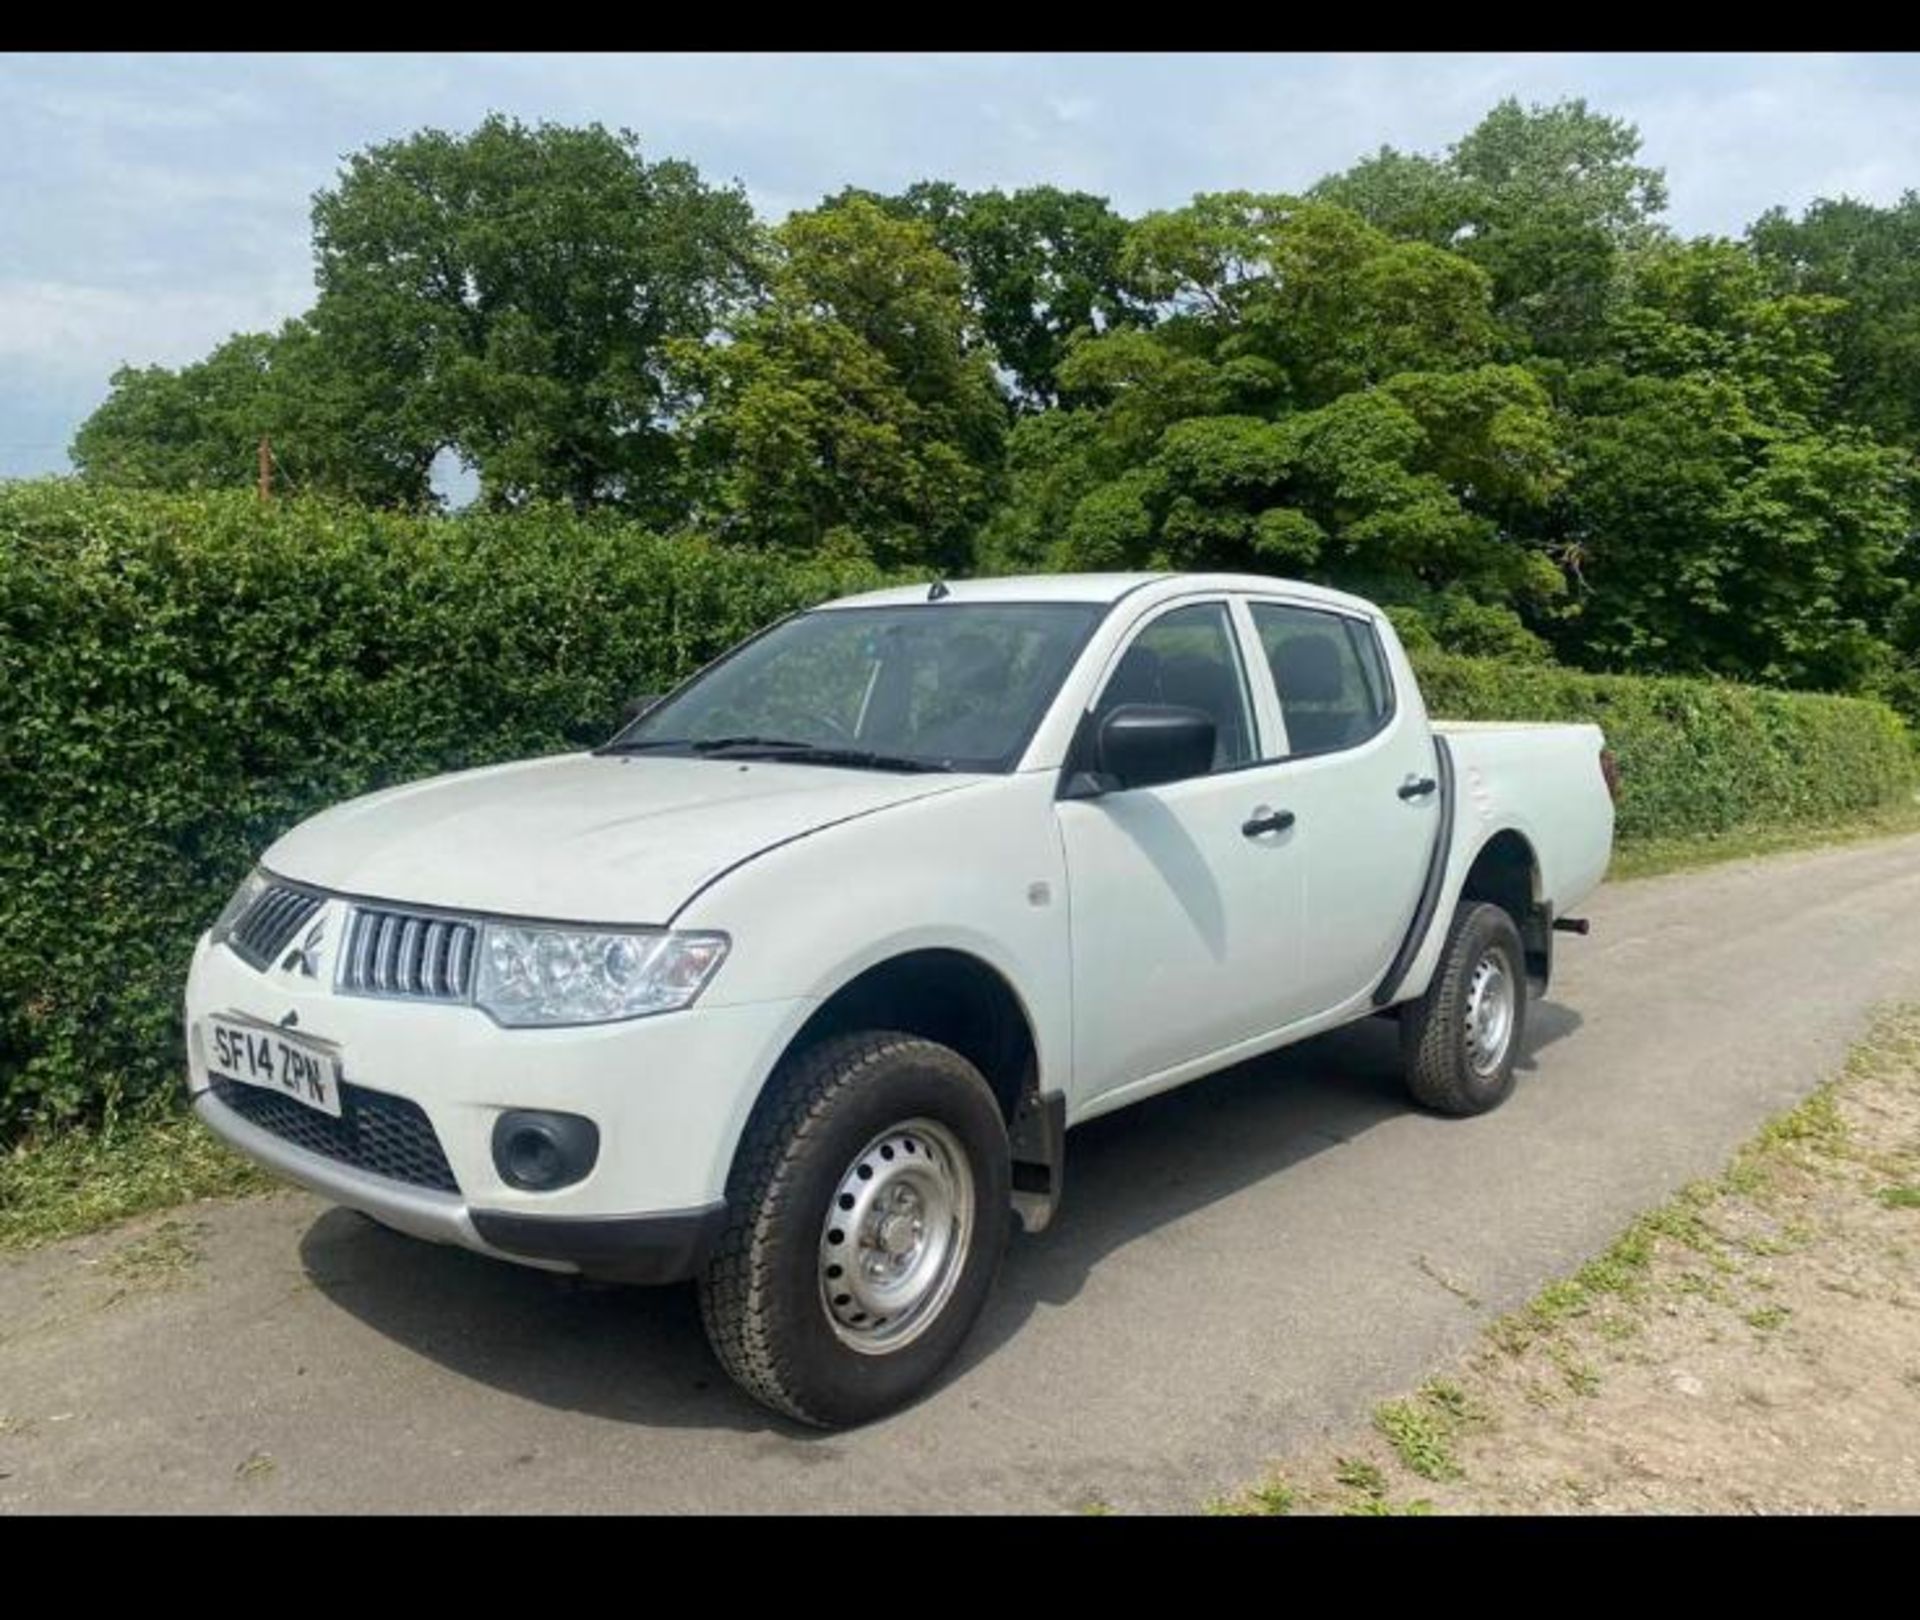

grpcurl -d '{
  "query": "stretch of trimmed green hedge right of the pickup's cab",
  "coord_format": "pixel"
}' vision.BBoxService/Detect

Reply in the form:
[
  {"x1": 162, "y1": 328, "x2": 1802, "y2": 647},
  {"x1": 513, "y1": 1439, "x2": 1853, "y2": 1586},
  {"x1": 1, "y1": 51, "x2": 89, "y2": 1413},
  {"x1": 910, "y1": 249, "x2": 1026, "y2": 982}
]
[{"x1": 1415, "y1": 655, "x2": 1914, "y2": 843}]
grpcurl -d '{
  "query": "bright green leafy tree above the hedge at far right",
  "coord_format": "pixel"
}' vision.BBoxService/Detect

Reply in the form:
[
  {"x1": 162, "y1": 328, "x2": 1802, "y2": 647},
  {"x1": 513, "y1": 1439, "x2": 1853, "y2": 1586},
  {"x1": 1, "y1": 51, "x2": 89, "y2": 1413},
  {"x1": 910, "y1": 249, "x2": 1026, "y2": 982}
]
[{"x1": 1559, "y1": 240, "x2": 1912, "y2": 691}]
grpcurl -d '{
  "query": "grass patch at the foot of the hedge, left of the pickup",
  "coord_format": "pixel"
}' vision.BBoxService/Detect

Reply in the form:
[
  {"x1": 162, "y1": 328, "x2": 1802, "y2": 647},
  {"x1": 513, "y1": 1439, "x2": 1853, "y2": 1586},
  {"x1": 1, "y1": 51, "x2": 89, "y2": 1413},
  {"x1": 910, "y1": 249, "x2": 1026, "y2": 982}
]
[{"x1": 0, "y1": 1102, "x2": 275, "y2": 1259}]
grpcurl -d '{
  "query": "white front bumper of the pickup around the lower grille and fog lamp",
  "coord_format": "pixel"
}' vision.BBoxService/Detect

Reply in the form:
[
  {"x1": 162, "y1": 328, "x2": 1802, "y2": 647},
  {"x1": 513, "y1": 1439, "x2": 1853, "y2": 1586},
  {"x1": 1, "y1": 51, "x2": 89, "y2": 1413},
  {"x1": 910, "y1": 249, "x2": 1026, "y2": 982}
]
[{"x1": 186, "y1": 900, "x2": 812, "y2": 1282}]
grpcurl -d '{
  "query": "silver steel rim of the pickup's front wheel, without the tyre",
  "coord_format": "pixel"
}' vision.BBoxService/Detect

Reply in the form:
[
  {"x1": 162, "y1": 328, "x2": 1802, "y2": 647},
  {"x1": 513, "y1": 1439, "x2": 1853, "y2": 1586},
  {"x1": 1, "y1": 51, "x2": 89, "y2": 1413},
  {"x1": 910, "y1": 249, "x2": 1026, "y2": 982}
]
[{"x1": 820, "y1": 1119, "x2": 973, "y2": 1355}]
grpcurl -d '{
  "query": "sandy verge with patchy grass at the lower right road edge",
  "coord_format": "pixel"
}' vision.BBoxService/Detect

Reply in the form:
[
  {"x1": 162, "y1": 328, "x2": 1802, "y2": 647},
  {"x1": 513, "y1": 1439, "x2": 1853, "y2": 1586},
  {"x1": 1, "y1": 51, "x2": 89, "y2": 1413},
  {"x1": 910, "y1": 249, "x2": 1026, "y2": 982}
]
[{"x1": 1208, "y1": 1004, "x2": 1920, "y2": 1514}]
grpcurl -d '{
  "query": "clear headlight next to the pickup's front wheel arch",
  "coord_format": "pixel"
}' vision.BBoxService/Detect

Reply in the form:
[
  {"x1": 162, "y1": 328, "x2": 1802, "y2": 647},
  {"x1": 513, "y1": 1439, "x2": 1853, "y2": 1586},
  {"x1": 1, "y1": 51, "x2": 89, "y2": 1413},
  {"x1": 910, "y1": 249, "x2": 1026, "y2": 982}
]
[{"x1": 474, "y1": 923, "x2": 728, "y2": 1025}]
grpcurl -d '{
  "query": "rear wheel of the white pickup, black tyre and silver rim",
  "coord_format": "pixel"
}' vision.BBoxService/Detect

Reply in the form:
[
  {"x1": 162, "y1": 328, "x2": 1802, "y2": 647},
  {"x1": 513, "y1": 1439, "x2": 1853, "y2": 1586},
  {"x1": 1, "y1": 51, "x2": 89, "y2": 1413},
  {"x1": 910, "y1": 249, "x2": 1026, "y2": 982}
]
[{"x1": 1400, "y1": 900, "x2": 1526, "y2": 1115}]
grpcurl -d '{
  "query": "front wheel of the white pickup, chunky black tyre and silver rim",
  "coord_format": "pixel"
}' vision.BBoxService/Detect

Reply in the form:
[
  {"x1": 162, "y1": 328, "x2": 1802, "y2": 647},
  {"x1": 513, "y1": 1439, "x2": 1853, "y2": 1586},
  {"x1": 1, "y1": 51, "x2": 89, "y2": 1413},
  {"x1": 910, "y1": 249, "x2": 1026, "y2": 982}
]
[{"x1": 699, "y1": 1031, "x2": 1012, "y2": 1428}]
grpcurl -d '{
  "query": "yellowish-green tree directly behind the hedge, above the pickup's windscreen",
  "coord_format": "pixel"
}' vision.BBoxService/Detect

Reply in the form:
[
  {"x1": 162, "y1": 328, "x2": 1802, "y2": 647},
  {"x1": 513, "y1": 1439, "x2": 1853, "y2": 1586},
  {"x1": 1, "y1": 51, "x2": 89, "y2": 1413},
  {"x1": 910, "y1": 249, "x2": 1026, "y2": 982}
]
[{"x1": 674, "y1": 200, "x2": 1006, "y2": 570}]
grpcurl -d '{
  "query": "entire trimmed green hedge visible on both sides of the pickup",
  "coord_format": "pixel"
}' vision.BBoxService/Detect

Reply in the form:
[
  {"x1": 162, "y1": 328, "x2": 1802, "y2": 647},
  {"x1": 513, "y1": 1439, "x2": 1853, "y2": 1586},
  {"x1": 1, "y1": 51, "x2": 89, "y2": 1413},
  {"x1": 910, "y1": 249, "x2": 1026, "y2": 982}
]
[{"x1": 0, "y1": 480, "x2": 1908, "y2": 1142}]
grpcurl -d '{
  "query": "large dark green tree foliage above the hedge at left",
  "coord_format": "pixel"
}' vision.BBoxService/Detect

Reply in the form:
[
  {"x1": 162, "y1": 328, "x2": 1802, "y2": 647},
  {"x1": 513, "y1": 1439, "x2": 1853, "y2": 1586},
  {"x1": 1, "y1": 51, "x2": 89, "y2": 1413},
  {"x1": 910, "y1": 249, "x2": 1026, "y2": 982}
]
[{"x1": 75, "y1": 115, "x2": 764, "y2": 520}]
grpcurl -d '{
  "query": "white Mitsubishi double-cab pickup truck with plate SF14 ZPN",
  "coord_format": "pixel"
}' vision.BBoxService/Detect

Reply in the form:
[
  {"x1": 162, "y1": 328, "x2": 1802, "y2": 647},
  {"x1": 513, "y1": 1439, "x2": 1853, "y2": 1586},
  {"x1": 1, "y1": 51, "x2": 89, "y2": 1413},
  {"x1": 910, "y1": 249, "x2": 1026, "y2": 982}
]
[{"x1": 186, "y1": 574, "x2": 1613, "y2": 1424}]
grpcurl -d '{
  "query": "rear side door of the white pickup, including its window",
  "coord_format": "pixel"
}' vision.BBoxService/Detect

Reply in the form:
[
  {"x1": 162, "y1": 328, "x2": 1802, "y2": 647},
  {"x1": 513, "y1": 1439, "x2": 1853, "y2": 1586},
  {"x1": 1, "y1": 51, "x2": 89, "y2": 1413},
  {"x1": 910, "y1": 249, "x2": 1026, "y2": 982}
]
[{"x1": 1246, "y1": 597, "x2": 1440, "y2": 1015}]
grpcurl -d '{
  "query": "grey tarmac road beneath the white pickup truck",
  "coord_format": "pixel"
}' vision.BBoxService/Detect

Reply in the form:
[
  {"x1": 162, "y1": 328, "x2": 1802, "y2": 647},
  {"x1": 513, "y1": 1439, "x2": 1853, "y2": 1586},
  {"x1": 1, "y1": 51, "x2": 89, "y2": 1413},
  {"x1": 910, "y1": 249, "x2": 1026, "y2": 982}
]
[{"x1": 0, "y1": 839, "x2": 1920, "y2": 1513}]
